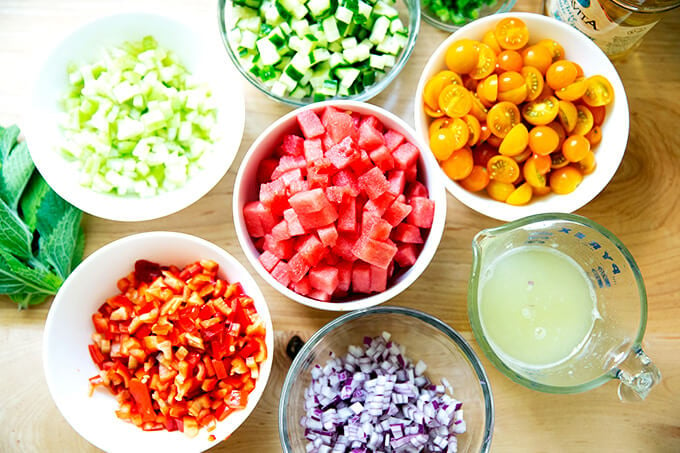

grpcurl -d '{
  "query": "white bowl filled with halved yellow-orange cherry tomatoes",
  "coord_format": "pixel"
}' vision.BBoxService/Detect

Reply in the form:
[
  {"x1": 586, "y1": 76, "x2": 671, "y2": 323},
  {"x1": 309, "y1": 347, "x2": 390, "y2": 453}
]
[{"x1": 415, "y1": 13, "x2": 629, "y2": 221}]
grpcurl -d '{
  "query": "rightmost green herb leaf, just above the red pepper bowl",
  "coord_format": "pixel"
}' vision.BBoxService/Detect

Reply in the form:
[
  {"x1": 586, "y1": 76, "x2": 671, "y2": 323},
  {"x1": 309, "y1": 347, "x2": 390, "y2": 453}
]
[{"x1": 38, "y1": 206, "x2": 82, "y2": 279}]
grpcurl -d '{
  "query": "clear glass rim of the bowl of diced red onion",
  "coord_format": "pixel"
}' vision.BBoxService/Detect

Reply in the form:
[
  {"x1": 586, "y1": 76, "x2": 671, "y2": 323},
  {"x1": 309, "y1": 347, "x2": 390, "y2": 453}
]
[{"x1": 279, "y1": 306, "x2": 495, "y2": 453}]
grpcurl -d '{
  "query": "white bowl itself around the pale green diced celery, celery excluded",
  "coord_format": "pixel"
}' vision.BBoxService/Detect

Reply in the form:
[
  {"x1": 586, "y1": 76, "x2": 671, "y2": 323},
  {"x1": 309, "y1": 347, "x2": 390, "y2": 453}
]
[{"x1": 25, "y1": 13, "x2": 245, "y2": 221}]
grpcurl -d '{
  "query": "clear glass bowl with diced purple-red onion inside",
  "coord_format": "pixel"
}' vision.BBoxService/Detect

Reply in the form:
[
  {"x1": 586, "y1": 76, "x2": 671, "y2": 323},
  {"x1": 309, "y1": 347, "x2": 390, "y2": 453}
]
[{"x1": 279, "y1": 307, "x2": 494, "y2": 453}]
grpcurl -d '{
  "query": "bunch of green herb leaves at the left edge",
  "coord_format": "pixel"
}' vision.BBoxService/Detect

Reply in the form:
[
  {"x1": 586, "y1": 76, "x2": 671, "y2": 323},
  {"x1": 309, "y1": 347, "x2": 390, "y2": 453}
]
[{"x1": 0, "y1": 126, "x2": 85, "y2": 308}]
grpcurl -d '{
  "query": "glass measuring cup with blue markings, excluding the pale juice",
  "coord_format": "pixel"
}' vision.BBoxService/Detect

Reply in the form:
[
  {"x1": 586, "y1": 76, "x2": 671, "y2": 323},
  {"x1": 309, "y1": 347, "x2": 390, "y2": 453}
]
[{"x1": 468, "y1": 214, "x2": 661, "y2": 401}]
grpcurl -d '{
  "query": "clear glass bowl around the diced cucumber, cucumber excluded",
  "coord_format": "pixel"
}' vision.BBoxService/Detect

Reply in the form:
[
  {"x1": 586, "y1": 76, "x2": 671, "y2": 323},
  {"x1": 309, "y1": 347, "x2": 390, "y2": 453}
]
[{"x1": 217, "y1": 0, "x2": 420, "y2": 107}]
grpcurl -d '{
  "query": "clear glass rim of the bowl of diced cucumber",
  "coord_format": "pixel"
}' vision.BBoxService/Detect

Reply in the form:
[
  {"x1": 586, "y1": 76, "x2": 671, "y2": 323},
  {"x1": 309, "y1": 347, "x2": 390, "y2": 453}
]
[{"x1": 217, "y1": 0, "x2": 420, "y2": 107}]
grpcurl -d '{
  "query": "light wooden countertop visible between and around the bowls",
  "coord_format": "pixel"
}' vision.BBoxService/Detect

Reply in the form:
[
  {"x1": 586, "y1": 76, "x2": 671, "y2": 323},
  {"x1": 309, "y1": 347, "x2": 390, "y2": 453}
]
[{"x1": 0, "y1": 0, "x2": 680, "y2": 453}]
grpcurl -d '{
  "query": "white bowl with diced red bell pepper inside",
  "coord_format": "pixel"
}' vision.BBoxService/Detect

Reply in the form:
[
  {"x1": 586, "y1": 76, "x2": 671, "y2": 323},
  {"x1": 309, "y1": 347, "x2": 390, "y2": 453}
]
[{"x1": 43, "y1": 232, "x2": 274, "y2": 452}]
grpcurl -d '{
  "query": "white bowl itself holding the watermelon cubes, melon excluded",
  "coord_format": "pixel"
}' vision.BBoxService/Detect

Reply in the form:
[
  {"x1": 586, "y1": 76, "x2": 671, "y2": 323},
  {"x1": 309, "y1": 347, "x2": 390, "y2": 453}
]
[{"x1": 233, "y1": 100, "x2": 446, "y2": 311}]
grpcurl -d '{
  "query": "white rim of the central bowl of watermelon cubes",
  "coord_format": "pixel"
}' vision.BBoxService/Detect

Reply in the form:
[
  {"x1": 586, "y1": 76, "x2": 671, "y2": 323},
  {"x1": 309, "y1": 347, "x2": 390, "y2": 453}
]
[{"x1": 232, "y1": 100, "x2": 446, "y2": 311}]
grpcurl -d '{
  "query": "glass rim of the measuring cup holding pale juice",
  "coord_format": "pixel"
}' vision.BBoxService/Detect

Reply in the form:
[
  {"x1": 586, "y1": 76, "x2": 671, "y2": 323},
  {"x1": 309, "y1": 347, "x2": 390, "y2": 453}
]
[{"x1": 468, "y1": 212, "x2": 647, "y2": 394}]
